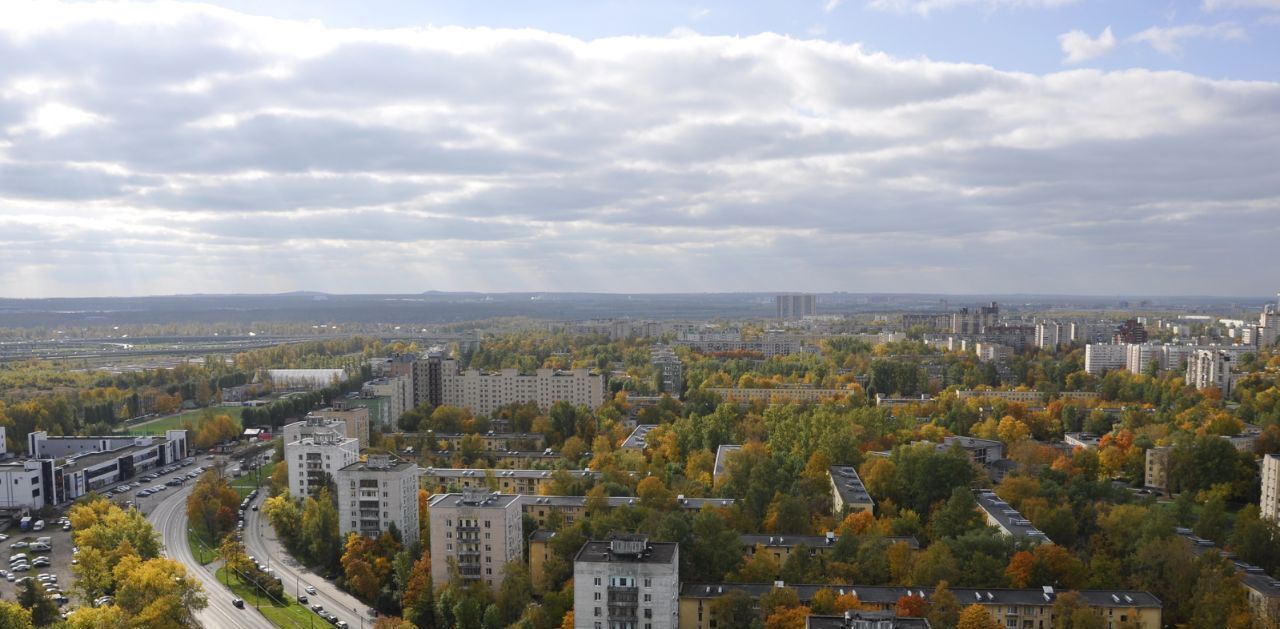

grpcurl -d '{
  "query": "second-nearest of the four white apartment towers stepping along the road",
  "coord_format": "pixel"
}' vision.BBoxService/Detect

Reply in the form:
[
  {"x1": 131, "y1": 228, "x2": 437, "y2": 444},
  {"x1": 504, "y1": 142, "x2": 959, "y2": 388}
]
[{"x1": 429, "y1": 489, "x2": 525, "y2": 591}]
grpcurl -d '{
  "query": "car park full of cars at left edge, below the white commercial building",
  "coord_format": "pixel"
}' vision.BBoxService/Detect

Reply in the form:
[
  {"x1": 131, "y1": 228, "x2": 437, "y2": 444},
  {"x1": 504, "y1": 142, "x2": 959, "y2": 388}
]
[{"x1": 0, "y1": 518, "x2": 74, "y2": 609}]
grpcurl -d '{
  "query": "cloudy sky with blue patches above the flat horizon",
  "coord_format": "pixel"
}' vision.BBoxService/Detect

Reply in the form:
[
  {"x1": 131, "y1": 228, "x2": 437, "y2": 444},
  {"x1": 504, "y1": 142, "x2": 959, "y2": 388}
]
[{"x1": 0, "y1": 0, "x2": 1280, "y2": 297}]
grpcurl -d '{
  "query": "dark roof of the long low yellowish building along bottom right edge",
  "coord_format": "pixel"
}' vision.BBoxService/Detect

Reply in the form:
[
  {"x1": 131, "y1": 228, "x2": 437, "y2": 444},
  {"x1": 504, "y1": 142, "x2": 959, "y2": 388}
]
[{"x1": 680, "y1": 583, "x2": 1162, "y2": 609}]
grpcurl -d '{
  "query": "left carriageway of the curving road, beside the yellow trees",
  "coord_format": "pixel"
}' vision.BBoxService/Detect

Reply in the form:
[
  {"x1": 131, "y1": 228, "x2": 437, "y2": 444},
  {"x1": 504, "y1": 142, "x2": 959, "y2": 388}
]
[{"x1": 147, "y1": 483, "x2": 274, "y2": 629}]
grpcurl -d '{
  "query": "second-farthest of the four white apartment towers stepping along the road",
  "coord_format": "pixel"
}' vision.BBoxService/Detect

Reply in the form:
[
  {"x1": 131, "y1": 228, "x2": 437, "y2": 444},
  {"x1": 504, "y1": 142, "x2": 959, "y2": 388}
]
[{"x1": 334, "y1": 455, "x2": 419, "y2": 546}]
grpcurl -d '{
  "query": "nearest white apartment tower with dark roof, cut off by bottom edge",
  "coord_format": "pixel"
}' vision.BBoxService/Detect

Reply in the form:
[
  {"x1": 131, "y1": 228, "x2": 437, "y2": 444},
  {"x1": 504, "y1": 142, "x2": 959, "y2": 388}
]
[{"x1": 573, "y1": 534, "x2": 680, "y2": 629}]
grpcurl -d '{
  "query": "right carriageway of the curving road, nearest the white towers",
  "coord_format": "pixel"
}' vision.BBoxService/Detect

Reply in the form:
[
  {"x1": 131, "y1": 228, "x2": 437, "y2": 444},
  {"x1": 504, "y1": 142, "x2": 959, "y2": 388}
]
[{"x1": 244, "y1": 491, "x2": 375, "y2": 629}]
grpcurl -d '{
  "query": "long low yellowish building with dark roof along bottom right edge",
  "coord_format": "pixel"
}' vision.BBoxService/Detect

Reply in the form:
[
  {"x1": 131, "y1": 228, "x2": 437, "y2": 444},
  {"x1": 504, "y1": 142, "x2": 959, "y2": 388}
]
[{"x1": 680, "y1": 583, "x2": 1164, "y2": 629}]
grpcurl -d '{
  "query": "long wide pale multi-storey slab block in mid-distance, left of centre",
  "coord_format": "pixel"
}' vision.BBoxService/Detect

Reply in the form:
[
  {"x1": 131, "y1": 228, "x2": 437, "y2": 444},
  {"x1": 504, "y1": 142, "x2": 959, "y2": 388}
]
[{"x1": 442, "y1": 360, "x2": 605, "y2": 415}]
